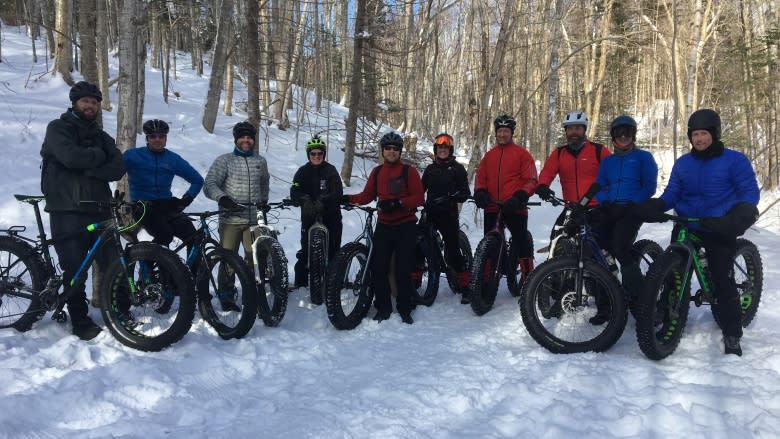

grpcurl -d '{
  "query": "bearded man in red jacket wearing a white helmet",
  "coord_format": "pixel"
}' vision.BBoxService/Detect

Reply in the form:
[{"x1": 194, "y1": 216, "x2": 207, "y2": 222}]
[{"x1": 536, "y1": 111, "x2": 611, "y2": 251}]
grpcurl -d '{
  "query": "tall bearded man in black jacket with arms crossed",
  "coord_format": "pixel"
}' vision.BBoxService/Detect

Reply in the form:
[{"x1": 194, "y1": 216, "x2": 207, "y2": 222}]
[{"x1": 41, "y1": 81, "x2": 125, "y2": 340}]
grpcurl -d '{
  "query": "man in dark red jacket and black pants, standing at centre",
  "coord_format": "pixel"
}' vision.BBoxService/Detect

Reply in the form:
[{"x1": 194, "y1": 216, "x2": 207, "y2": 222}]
[{"x1": 342, "y1": 132, "x2": 425, "y2": 325}]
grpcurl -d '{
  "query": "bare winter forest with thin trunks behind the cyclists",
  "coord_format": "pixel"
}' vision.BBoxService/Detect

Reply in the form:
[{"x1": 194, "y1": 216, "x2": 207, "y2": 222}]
[{"x1": 0, "y1": 0, "x2": 780, "y2": 194}]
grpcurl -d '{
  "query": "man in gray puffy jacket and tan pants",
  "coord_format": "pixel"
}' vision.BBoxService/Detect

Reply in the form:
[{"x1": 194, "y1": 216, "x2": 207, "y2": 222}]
[{"x1": 203, "y1": 122, "x2": 269, "y2": 311}]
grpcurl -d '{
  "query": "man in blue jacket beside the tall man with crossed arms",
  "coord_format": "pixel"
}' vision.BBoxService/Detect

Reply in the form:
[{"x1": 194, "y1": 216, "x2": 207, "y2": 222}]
[{"x1": 123, "y1": 119, "x2": 203, "y2": 246}]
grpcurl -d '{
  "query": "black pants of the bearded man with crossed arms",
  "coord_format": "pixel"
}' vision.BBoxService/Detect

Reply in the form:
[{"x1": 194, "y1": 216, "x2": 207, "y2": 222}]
[{"x1": 49, "y1": 212, "x2": 116, "y2": 323}]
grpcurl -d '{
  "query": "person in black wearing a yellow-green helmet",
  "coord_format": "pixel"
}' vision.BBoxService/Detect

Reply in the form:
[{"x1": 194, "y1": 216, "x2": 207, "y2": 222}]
[{"x1": 290, "y1": 136, "x2": 344, "y2": 298}]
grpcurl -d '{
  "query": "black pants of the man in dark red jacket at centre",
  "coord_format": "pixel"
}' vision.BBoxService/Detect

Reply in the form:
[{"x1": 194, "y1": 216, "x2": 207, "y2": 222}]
[{"x1": 371, "y1": 222, "x2": 417, "y2": 314}]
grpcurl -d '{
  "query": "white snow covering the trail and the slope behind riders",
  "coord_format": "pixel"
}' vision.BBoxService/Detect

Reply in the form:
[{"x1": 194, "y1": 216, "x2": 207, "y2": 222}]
[{"x1": 0, "y1": 27, "x2": 780, "y2": 438}]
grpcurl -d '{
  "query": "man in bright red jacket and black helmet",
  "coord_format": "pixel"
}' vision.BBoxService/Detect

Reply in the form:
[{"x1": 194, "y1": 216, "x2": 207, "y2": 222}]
[{"x1": 473, "y1": 114, "x2": 537, "y2": 300}]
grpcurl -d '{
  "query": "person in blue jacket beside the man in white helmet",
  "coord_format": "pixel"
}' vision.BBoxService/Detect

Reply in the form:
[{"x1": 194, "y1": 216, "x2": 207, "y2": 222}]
[{"x1": 590, "y1": 115, "x2": 658, "y2": 325}]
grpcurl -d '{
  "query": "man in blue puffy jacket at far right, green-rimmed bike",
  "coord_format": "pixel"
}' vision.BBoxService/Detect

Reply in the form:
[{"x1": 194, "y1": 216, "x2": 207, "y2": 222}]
[{"x1": 638, "y1": 109, "x2": 760, "y2": 356}]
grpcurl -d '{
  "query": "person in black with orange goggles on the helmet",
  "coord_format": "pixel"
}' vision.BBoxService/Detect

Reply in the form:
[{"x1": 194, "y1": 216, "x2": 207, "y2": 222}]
[{"x1": 420, "y1": 133, "x2": 471, "y2": 289}]
